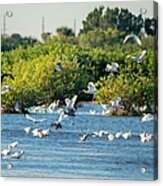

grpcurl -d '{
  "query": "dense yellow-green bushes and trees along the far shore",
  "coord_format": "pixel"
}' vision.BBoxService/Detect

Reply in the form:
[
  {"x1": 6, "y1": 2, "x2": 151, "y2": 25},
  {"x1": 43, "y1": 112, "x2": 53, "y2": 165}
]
[{"x1": 2, "y1": 7, "x2": 157, "y2": 112}]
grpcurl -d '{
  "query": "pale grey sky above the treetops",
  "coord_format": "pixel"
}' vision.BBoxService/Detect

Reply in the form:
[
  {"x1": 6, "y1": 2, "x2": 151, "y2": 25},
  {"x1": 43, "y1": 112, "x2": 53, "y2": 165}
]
[{"x1": 0, "y1": 1, "x2": 153, "y2": 38}]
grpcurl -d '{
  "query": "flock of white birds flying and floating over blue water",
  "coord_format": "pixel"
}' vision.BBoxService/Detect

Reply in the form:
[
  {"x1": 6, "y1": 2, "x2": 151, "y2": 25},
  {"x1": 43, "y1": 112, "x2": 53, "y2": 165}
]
[{"x1": 1, "y1": 34, "x2": 157, "y2": 169}]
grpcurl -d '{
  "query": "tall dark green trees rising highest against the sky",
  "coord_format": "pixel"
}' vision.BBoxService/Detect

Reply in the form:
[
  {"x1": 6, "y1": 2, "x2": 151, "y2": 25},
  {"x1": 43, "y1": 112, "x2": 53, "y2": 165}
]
[{"x1": 79, "y1": 6, "x2": 156, "y2": 35}]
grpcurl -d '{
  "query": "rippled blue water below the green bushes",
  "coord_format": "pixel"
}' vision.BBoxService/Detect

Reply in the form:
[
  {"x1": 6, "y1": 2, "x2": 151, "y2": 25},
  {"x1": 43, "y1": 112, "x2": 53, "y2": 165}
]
[{"x1": 1, "y1": 104, "x2": 155, "y2": 180}]
